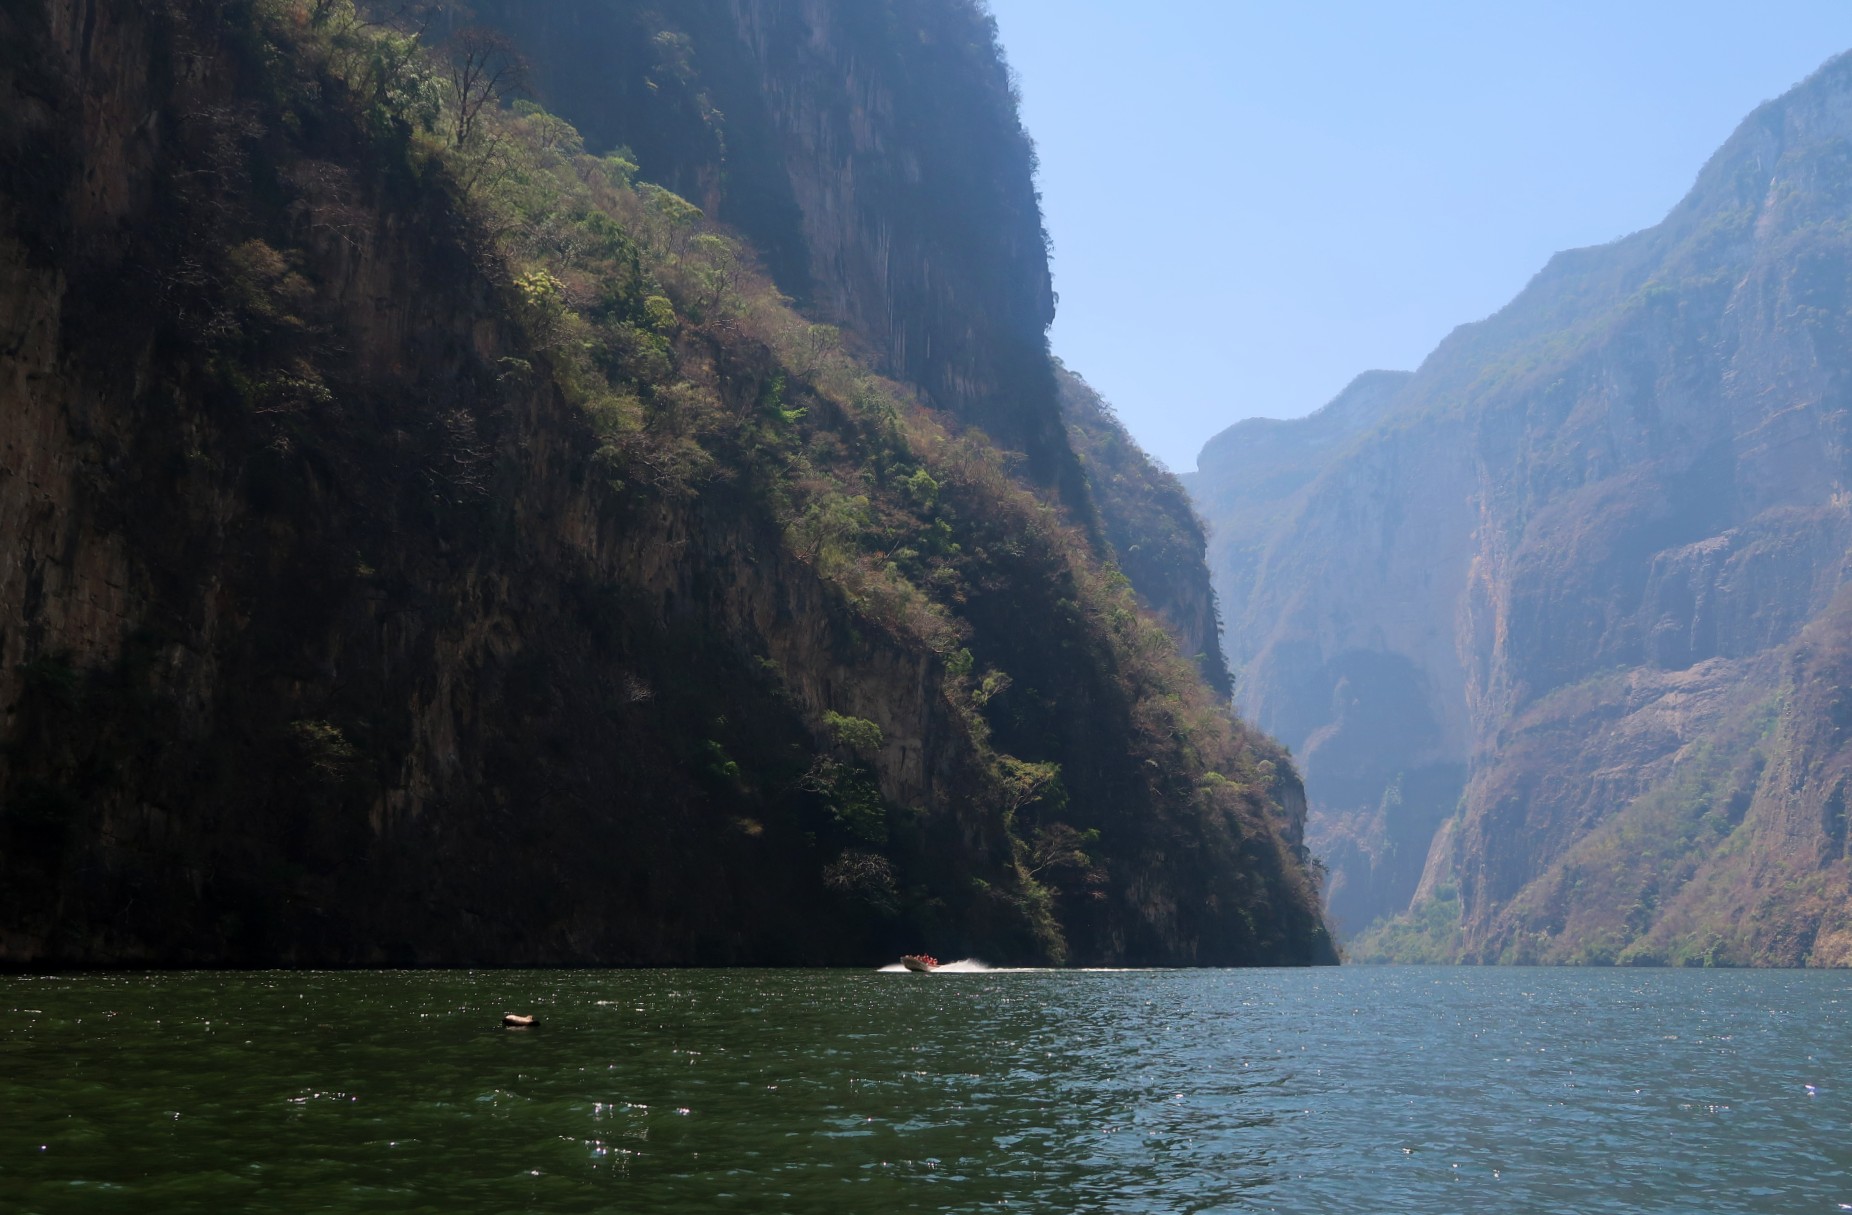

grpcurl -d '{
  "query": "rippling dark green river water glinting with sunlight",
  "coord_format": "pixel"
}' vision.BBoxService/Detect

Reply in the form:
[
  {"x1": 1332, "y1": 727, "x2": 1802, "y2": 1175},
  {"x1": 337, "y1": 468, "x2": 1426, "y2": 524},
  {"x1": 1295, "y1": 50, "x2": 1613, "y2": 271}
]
[{"x1": 0, "y1": 969, "x2": 1852, "y2": 1215}]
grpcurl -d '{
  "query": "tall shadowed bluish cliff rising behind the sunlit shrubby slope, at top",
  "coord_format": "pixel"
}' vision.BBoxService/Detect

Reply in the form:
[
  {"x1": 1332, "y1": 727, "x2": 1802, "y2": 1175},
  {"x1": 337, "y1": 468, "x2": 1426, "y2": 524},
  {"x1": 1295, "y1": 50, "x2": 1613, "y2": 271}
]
[{"x1": 455, "y1": 0, "x2": 1085, "y2": 515}]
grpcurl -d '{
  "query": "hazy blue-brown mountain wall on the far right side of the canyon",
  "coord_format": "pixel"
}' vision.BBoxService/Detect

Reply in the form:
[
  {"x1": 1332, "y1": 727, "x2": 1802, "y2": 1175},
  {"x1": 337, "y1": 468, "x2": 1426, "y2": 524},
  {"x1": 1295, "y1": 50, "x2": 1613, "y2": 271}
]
[{"x1": 1193, "y1": 59, "x2": 1852, "y2": 965}]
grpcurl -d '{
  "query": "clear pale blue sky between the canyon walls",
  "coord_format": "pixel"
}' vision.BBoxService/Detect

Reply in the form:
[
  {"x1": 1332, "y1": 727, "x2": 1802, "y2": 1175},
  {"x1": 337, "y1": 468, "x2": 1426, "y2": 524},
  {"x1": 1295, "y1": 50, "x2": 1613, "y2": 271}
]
[{"x1": 991, "y1": 0, "x2": 1852, "y2": 470}]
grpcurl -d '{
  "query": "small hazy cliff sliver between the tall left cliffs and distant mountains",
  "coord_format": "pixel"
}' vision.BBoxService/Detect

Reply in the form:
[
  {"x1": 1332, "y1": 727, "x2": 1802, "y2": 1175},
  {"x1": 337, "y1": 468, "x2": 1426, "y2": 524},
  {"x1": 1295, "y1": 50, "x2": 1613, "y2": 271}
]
[{"x1": 1056, "y1": 365, "x2": 1233, "y2": 698}]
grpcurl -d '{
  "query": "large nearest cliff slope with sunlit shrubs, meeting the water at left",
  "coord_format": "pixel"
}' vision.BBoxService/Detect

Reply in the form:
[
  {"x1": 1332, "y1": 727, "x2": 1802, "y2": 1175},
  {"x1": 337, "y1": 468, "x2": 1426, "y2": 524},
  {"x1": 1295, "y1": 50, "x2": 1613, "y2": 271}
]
[{"x1": 0, "y1": 0, "x2": 1330, "y2": 963}]
